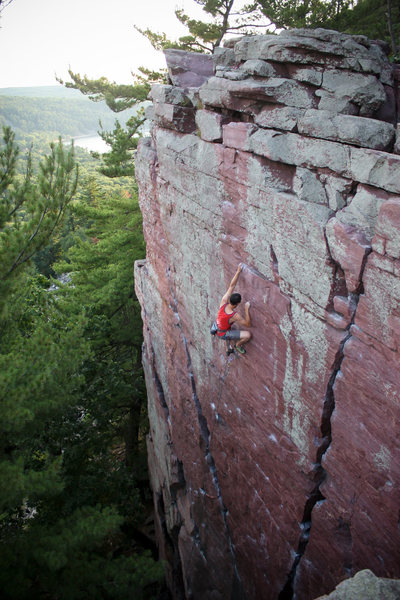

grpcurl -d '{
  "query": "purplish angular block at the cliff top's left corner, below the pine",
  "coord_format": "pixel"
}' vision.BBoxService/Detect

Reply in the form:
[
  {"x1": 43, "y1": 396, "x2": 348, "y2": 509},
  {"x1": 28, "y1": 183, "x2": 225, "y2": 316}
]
[{"x1": 164, "y1": 48, "x2": 214, "y2": 88}]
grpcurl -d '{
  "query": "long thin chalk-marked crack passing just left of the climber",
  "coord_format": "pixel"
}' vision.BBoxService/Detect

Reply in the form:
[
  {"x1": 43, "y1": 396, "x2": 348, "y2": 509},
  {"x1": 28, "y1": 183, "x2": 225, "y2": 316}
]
[{"x1": 167, "y1": 270, "x2": 245, "y2": 600}]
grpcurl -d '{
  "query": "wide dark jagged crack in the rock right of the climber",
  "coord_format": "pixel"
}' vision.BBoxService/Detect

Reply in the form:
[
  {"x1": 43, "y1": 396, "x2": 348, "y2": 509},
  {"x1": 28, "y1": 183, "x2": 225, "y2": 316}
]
[{"x1": 278, "y1": 240, "x2": 371, "y2": 600}]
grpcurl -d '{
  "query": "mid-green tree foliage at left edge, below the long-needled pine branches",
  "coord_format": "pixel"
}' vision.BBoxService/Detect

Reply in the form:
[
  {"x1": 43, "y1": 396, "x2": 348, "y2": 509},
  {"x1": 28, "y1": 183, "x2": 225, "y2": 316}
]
[{"x1": 0, "y1": 275, "x2": 88, "y2": 510}]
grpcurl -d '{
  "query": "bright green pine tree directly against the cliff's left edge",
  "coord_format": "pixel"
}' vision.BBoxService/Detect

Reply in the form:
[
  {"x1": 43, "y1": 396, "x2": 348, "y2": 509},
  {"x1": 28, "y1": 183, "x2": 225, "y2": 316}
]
[{"x1": 58, "y1": 177, "x2": 145, "y2": 464}]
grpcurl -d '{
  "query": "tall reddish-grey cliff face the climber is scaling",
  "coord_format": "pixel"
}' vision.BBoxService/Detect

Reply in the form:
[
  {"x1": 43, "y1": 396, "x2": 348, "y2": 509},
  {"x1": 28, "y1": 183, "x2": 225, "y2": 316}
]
[{"x1": 135, "y1": 30, "x2": 400, "y2": 600}]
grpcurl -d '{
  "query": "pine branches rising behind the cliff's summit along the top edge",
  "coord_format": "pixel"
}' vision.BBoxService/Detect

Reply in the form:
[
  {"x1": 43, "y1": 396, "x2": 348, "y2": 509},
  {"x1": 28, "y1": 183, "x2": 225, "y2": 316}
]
[{"x1": 136, "y1": 0, "x2": 400, "y2": 54}]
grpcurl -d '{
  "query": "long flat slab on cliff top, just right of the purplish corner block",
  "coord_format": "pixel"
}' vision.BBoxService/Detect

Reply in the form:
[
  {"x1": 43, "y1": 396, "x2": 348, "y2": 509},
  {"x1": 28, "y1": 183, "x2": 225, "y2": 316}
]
[{"x1": 200, "y1": 77, "x2": 317, "y2": 110}]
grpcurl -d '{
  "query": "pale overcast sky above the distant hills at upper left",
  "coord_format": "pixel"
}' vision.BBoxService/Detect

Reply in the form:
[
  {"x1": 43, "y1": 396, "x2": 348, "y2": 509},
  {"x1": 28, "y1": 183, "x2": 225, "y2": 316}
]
[{"x1": 0, "y1": 0, "x2": 204, "y2": 88}]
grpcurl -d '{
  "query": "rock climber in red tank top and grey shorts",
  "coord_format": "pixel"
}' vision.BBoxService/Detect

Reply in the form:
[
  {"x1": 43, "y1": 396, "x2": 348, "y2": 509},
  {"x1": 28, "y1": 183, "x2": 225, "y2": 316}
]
[{"x1": 217, "y1": 263, "x2": 251, "y2": 354}]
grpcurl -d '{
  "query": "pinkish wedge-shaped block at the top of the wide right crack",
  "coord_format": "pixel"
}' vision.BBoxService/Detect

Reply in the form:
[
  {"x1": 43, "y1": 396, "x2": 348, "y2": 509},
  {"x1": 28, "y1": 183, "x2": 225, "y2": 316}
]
[{"x1": 326, "y1": 217, "x2": 371, "y2": 293}]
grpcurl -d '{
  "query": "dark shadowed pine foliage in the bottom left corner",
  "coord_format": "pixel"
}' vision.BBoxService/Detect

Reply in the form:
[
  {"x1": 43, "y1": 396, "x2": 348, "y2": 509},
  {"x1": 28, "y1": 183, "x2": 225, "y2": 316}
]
[{"x1": 0, "y1": 506, "x2": 162, "y2": 600}]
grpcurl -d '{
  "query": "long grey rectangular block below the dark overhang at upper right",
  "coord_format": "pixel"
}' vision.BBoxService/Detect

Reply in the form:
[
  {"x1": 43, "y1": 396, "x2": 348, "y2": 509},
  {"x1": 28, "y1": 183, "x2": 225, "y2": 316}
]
[{"x1": 298, "y1": 109, "x2": 395, "y2": 150}]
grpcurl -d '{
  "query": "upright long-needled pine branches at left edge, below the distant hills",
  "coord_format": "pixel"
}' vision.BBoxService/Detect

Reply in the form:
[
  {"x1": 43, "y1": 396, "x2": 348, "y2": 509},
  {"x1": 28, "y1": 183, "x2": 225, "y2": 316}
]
[{"x1": 0, "y1": 128, "x2": 78, "y2": 313}]
